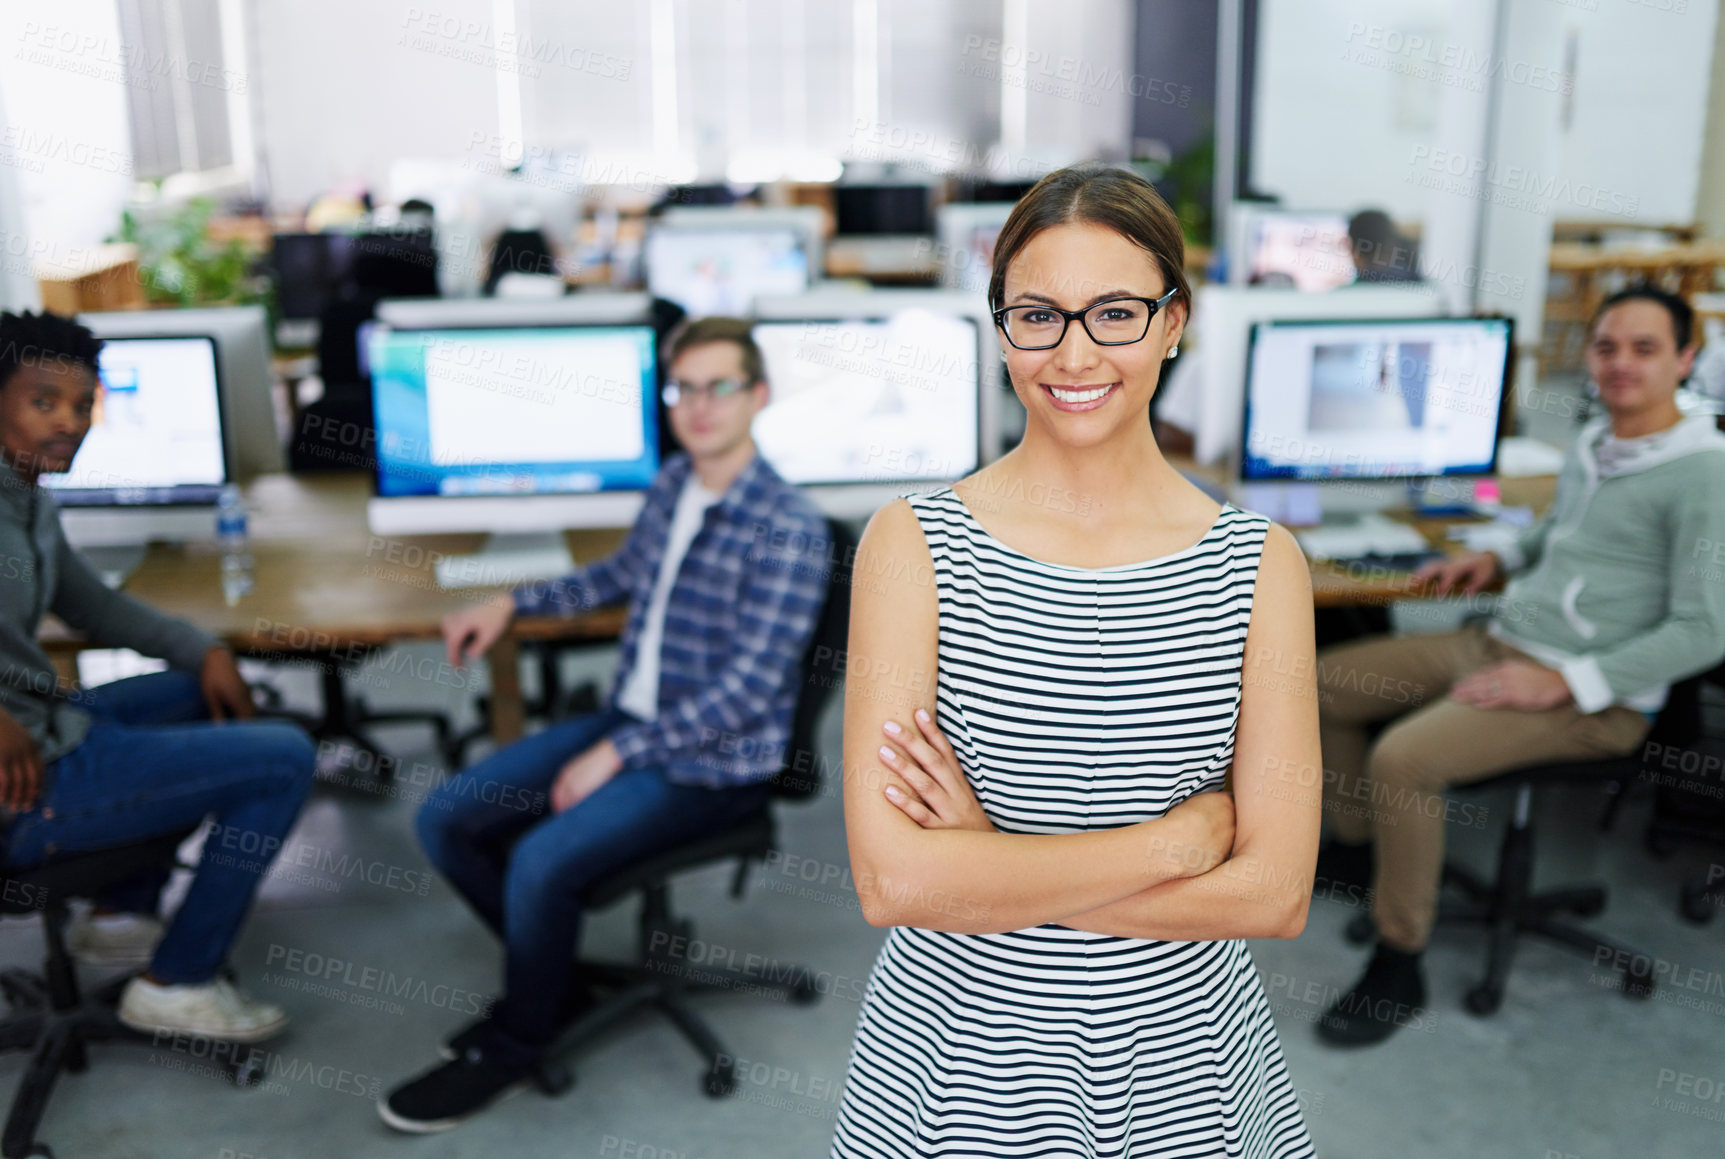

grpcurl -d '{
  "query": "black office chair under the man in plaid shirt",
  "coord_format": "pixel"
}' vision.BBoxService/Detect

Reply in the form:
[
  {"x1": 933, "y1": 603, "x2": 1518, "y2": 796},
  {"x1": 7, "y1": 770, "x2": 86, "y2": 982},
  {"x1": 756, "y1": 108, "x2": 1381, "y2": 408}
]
[{"x1": 536, "y1": 519, "x2": 856, "y2": 1099}]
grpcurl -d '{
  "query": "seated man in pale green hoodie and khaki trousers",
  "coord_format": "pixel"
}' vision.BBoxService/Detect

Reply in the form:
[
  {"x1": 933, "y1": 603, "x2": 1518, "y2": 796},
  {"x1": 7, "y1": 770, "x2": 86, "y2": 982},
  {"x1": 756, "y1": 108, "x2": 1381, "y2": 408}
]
[{"x1": 1318, "y1": 286, "x2": 1725, "y2": 1045}]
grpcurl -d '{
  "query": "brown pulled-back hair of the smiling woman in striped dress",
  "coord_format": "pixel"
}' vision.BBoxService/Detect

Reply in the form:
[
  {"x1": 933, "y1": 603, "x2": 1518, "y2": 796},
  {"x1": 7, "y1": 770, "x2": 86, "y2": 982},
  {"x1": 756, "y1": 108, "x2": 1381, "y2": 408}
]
[{"x1": 988, "y1": 164, "x2": 1192, "y2": 310}]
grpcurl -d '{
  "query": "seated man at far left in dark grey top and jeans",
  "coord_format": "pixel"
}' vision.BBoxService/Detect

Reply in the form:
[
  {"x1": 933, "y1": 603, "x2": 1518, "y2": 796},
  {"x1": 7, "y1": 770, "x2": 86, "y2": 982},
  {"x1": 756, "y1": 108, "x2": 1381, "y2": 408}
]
[{"x1": 0, "y1": 314, "x2": 314, "y2": 1042}]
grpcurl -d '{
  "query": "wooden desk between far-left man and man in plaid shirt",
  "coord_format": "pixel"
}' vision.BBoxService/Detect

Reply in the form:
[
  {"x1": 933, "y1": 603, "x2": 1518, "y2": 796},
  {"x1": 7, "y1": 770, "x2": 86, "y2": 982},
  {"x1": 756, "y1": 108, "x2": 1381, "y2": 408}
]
[{"x1": 41, "y1": 473, "x2": 624, "y2": 743}]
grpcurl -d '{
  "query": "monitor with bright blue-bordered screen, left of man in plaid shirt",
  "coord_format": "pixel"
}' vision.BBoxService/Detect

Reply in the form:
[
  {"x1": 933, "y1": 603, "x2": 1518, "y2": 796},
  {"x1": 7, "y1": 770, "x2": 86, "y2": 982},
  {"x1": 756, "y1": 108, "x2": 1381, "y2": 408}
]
[{"x1": 367, "y1": 324, "x2": 659, "y2": 535}]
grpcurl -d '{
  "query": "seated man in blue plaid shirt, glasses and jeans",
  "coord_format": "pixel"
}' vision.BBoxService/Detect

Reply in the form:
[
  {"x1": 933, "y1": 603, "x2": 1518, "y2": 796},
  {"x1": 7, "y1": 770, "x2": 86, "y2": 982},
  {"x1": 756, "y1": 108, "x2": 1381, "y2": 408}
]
[{"x1": 378, "y1": 317, "x2": 830, "y2": 1131}]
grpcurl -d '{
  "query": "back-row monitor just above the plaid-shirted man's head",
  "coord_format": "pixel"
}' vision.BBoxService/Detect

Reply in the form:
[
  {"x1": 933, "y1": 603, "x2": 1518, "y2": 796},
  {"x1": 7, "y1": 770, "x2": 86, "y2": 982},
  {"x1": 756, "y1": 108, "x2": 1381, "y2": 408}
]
[{"x1": 645, "y1": 224, "x2": 811, "y2": 317}]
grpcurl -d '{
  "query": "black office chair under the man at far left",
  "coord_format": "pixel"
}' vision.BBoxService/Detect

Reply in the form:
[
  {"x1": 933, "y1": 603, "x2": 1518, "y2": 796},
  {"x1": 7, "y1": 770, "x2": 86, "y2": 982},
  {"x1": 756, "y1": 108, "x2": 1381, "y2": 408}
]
[{"x1": 0, "y1": 830, "x2": 262, "y2": 1159}]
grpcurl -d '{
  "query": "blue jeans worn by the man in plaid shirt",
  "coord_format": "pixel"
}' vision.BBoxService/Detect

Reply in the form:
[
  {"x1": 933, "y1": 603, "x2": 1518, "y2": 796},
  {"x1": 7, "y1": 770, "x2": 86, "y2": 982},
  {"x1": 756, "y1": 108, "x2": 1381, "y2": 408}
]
[{"x1": 417, "y1": 711, "x2": 768, "y2": 1061}]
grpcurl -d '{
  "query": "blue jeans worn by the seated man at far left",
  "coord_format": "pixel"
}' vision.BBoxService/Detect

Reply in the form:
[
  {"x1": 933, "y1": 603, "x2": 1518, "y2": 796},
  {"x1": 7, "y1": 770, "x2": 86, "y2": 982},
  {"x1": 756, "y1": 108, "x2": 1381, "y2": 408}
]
[{"x1": 5, "y1": 671, "x2": 316, "y2": 985}]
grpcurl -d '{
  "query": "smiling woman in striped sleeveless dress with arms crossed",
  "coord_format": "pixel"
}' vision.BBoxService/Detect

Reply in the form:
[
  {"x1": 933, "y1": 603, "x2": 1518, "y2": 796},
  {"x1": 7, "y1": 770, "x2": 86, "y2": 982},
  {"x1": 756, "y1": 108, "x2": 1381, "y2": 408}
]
[{"x1": 833, "y1": 167, "x2": 1320, "y2": 1159}]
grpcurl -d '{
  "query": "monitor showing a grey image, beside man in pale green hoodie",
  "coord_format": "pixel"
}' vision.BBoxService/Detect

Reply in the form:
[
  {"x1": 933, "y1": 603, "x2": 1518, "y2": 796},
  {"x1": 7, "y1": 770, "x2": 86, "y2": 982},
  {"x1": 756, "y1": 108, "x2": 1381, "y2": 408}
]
[{"x1": 1240, "y1": 317, "x2": 1515, "y2": 481}]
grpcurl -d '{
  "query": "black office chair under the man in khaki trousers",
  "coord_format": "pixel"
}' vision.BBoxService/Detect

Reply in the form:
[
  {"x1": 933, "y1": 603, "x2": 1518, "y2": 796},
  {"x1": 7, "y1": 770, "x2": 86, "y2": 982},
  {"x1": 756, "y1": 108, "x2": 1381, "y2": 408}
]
[{"x1": 1347, "y1": 676, "x2": 1701, "y2": 1018}]
